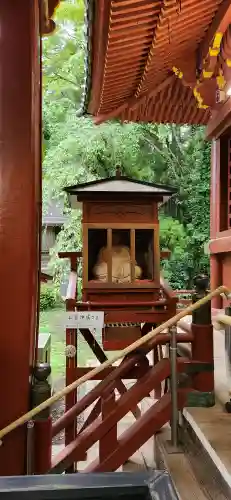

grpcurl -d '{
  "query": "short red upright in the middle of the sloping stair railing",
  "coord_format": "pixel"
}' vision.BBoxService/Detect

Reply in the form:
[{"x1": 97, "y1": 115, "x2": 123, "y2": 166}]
[{"x1": 99, "y1": 389, "x2": 118, "y2": 462}]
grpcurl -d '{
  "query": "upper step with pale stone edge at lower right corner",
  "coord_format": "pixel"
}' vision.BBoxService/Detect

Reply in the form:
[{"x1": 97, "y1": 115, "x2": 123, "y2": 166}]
[{"x1": 180, "y1": 403, "x2": 231, "y2": 500}]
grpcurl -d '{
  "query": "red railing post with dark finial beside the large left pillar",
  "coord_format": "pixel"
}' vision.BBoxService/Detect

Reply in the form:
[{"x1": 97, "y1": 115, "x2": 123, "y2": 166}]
[{"x1": 30, "y1": 363, "x2": 52, "y2": 474}]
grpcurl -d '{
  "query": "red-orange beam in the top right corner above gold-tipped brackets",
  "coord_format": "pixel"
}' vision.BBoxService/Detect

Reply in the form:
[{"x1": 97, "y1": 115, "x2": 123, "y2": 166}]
[{"x1": 199, "y1": 0, "x2": 231, "y2": 60}]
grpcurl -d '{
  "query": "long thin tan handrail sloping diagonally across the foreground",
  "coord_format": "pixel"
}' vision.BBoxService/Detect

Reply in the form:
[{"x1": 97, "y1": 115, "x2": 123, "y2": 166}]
[{"x1": 0, "y1": 286, "x2": 230, "y2": 440}]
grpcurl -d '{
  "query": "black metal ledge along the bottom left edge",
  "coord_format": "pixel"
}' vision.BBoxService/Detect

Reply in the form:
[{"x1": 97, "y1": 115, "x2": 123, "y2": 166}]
[{"x1": 0, "y1": 471, "x2": 178, "y2": 500}]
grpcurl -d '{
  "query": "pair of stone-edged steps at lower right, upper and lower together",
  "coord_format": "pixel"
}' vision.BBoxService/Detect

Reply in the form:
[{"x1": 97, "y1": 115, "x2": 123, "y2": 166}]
[{"x1": 155, "y1": 403, "x2": 231, "y2": 500}]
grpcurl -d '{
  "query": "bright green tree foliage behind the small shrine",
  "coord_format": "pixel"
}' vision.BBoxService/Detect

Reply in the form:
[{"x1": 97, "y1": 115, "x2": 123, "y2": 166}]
[{"x1": 43, "y1": 0, "x2": 210, "y2": 288}]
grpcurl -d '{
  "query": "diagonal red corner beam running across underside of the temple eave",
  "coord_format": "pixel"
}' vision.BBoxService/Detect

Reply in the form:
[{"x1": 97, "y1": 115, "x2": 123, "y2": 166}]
[{"x1": 94, "y1": 73, "x2": 175, "y2": 125}]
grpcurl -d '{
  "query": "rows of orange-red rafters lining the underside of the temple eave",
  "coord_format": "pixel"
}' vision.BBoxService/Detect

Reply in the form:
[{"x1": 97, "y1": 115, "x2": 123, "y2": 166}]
[{"x1": 85, "y1": 0, "x2": 223, "y2": 124}]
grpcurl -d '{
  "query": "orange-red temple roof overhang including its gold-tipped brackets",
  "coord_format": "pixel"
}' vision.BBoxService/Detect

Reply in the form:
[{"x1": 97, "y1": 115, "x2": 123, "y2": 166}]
[{"x1": 79, "y1": 0, "x2": 231, "y2": 129}]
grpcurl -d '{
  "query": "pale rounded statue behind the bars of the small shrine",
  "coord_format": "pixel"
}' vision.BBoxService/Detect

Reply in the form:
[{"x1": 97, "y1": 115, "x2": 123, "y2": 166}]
[{"x1": 93, "y1": 232, "x2": 142, "y2": 283}]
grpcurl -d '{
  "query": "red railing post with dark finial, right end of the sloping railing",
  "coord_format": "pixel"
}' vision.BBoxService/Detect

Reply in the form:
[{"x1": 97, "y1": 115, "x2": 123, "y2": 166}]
[{"x1": 190, "y1": 275, "x2": 215, "y2": 406}]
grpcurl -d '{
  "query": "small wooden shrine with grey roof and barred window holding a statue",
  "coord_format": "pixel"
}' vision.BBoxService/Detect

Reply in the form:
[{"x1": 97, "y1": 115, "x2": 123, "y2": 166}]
[{"x1": 66, "y1": 169, "x2": 174, "y2": 350}]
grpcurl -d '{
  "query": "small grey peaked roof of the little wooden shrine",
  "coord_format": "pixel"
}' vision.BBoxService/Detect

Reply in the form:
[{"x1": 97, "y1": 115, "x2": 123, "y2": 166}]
[{"x1": 65, "y1": 176, "x2": 176, "y2": 197}]
